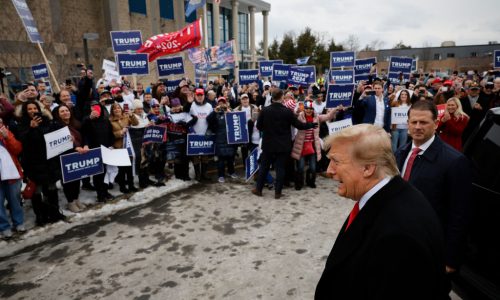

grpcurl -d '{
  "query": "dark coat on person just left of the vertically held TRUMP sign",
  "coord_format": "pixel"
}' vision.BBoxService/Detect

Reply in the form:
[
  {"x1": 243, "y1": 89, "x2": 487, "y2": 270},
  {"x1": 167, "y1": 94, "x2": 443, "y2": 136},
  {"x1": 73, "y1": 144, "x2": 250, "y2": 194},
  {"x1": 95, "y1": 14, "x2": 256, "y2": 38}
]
[{"x1": 207, "y1": 107, "x2": 236, "y2": 156}]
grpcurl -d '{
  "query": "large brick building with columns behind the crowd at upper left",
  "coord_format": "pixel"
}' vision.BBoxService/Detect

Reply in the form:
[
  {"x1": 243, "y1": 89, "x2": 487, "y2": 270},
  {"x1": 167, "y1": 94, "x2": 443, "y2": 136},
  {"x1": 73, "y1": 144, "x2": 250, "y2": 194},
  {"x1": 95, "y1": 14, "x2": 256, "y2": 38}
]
[{"x1": 0, "y1": 0, "x2": 271, "y2": 92}]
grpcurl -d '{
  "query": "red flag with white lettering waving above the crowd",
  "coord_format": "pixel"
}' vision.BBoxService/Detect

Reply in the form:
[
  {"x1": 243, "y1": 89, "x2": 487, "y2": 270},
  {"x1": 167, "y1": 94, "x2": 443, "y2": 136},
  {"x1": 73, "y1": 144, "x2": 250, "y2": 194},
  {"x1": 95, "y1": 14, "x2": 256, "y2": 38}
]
[{"x1": 137, "y1": 19, "x2": 202, "y2": 62}]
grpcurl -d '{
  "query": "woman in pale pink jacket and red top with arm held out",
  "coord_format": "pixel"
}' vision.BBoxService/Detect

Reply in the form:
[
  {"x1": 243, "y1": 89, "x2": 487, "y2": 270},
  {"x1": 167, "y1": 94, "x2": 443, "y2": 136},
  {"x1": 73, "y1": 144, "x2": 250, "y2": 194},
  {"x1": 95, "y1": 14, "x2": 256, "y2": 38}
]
[{"x1": 291, "y1": 101, "x2": 341, "y2": 190}]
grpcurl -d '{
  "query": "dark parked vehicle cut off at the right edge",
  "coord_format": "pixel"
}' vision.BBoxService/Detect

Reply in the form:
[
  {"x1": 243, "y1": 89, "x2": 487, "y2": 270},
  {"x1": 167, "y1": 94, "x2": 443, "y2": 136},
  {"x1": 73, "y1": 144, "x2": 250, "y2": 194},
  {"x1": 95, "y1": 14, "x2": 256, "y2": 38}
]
[{"x1": 453, "y1": 107, "x2": 500, "y2": 300}]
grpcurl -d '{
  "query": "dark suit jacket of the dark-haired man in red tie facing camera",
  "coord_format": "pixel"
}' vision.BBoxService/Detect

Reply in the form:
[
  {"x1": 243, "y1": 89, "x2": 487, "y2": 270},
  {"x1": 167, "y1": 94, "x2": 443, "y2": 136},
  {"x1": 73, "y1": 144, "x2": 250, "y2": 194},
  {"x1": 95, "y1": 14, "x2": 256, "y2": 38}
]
[{"x1": 395, "y1": 136, "x2": 473, "y2": 268}]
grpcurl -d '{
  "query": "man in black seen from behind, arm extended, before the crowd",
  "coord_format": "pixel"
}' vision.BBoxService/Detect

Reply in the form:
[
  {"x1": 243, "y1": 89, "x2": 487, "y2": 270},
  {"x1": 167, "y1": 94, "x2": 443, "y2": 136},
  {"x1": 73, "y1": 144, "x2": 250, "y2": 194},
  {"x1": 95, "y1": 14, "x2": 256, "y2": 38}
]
[{"x1": 252, "y1": 89, "x2": 318, "y2": 199}]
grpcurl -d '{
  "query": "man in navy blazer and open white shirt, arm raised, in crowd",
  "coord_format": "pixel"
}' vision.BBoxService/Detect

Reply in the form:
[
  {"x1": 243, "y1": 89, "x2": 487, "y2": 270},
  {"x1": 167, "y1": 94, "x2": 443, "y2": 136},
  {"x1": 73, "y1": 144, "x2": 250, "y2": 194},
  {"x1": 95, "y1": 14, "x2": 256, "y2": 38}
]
[{"x1": 355, "y1": 82, "x2": 391, "y2": 132}]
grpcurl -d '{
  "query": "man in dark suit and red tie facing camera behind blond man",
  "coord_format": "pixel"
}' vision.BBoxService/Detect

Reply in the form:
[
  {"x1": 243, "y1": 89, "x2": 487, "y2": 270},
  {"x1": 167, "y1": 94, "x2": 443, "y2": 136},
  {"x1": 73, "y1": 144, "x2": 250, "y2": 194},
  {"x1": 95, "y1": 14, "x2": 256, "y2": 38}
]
[{"x1": 395, "y1": 101, "x2": 472, "y2": 274}]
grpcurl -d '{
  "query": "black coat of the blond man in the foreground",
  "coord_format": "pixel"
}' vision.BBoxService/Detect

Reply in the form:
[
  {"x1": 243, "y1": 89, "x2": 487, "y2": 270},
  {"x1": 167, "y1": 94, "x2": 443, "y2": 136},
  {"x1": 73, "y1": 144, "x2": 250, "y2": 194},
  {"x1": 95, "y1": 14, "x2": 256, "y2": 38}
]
[{"x1": 315, "y1": 176, "x2": 450, "y2": 300}]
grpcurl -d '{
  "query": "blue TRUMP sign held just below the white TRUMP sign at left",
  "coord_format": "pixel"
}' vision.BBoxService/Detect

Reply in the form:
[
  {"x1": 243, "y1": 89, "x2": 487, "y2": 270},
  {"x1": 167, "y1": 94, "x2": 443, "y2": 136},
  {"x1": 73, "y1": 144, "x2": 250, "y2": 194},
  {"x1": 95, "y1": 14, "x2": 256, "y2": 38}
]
[{"x1": 60, "y1": 148, "x2": 104, "y2": 183}]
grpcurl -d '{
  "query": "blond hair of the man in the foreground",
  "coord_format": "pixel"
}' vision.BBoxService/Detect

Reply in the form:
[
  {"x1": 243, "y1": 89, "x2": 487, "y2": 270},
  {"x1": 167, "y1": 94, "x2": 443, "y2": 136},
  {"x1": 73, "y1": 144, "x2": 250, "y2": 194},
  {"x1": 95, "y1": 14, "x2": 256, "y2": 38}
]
[{"x1": 324, "y1": 124, "x2": 399, "y2": 178}]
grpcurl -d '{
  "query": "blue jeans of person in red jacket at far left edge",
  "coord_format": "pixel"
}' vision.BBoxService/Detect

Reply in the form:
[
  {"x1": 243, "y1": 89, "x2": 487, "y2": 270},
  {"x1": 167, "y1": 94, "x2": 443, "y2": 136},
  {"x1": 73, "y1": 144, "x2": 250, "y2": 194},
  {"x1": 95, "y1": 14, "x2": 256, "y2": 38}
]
[{"x1": 0, "y1": 179, "x2": 24, "y2": 231}]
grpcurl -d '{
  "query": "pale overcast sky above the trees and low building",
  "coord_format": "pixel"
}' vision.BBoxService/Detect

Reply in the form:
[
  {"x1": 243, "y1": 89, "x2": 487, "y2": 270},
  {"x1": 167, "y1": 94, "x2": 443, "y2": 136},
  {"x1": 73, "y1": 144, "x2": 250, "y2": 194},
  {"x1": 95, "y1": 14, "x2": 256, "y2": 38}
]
[{"x1": 255, "y1": 0, "x2": 500, "y2": 49}]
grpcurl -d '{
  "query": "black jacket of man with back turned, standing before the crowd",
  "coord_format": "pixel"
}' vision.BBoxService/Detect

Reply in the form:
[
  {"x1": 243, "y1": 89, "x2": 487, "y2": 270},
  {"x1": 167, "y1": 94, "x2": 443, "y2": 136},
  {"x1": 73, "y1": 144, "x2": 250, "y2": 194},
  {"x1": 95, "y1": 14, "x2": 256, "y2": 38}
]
[{"x1": 257, "y1": 102, "x2": 311, "y2": 153}]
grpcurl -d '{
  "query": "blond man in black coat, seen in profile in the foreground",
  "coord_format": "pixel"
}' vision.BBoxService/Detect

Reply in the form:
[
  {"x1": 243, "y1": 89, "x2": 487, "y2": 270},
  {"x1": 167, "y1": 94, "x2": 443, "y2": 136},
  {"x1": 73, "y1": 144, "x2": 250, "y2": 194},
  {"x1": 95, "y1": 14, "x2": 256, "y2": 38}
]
[{"x1": 315, "y1": 124, "x2": 449, "y2": 300}]
